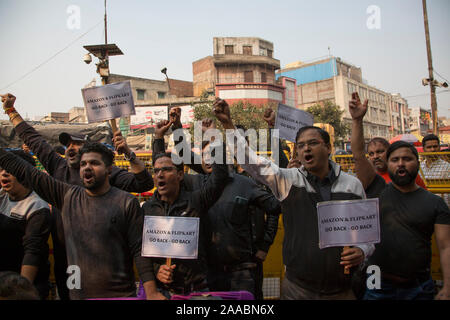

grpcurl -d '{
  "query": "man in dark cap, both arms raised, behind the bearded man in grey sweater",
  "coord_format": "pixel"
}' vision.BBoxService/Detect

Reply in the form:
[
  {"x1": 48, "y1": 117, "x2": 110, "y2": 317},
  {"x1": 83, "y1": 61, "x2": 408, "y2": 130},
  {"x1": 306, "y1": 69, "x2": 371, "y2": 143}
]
[{"x1": 2, "y1": 94, "x2": 153, "y2": 300}]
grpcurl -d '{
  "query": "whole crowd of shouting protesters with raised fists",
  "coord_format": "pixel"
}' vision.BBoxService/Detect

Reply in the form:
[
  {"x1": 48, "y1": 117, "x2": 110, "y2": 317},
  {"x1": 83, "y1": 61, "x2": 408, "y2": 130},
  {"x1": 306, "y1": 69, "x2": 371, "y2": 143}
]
[{"x1": 0, "y1": 93, "x2": 450, "y2": 300}]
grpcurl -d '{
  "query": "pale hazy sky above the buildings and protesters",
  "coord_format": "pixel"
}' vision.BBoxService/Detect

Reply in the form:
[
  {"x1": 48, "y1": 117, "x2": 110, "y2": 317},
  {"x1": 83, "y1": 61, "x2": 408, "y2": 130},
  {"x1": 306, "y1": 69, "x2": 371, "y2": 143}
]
[{"x1": 0, "y1": 0, "x2": 450, "y2": 119}]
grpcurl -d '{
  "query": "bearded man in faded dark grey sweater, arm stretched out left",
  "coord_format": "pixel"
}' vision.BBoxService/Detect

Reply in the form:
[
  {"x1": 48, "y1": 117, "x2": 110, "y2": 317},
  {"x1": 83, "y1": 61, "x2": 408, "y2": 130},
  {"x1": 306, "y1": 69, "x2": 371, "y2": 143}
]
[{"x1": 0, "y1": 143, "x2": 163, "y2": 299}]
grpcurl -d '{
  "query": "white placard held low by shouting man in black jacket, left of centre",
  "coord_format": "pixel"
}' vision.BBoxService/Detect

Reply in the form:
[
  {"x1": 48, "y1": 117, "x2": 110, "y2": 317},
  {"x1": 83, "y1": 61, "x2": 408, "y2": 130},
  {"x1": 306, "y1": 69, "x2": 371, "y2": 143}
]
[{"x1": 142, "y1": 216, "x2": 200, "y2": 259}]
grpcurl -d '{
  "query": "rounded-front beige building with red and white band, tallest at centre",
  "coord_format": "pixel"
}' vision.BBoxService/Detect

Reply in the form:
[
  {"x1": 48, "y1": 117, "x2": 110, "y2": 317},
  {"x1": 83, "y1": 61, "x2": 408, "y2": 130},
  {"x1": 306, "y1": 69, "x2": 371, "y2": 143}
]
[{"x1": 192, "y1": 37, "x2": 296, "y2": 107}]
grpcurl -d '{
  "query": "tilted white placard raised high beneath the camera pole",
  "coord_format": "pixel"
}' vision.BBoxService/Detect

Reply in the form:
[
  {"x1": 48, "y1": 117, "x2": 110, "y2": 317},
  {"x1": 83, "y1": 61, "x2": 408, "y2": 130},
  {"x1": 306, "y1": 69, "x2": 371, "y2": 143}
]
[{"x1": 81, "y1": 81, "x2": 135, "y2": 123}]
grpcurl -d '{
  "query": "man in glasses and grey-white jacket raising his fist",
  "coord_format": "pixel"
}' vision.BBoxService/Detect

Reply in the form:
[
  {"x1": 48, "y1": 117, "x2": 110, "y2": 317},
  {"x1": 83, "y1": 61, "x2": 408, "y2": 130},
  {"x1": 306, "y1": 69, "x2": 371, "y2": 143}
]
[{"x1": 213, "y1": 99, "x2": 373, "y2": 300}]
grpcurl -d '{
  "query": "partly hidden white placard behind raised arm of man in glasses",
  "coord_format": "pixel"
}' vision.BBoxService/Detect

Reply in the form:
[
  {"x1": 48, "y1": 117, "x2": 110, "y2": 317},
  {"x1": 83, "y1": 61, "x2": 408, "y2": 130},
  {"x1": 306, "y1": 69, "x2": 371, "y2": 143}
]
[{"x1": 275, "y1": 103, "x2": 314, "y2": 142}]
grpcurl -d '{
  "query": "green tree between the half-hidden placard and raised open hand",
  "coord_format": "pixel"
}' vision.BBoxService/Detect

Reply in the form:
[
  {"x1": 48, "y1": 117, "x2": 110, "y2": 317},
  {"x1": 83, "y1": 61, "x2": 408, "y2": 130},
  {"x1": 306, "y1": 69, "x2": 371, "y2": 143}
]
[{"x1": 306, "y1": 101, "x2": 350, "y2": 143}]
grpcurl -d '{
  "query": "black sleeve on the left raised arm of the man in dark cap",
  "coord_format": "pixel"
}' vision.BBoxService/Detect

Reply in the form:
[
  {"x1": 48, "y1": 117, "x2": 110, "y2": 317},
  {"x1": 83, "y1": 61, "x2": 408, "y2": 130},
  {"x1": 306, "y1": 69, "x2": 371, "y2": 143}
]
[{"x1": 15, "y1": 121, "x2": 66, "y2": 175}]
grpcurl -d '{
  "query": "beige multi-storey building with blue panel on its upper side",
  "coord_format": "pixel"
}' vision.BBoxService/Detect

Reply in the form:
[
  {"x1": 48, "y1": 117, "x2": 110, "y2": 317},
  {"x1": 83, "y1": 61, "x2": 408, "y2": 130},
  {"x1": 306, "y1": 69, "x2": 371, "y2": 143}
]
[{"x1": 276, "y1": 57, "x2": 400, "y2": 140}]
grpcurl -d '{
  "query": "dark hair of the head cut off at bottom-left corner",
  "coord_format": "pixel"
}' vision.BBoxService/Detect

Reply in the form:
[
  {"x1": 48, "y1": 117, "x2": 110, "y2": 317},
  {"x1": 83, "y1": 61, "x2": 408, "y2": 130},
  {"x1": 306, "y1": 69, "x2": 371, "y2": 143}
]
[{"x1": 0, "y1": 271, "x2": 40, "y2": 300}]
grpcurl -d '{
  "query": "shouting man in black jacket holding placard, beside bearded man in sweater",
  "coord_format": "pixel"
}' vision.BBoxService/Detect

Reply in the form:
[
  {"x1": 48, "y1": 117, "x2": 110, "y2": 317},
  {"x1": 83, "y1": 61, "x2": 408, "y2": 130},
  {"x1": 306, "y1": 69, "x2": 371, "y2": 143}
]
[{"x1": 143, "y1": 144, "x2": 227, "y2": 297}]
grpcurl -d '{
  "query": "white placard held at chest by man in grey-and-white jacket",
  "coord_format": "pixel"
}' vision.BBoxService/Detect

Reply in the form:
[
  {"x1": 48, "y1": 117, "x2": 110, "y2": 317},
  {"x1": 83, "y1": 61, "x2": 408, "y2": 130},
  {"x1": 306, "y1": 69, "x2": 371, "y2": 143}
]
[{"x1": 317, "y1": 198, "x2": 380, "y2": 249}]
